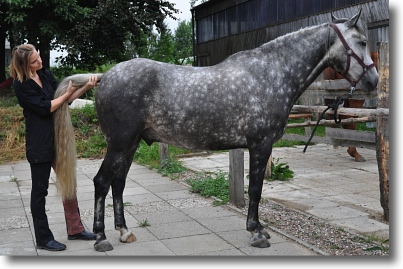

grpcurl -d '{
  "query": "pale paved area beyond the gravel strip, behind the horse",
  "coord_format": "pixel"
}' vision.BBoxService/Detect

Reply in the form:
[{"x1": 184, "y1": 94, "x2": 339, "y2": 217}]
[{"x1": 180, "y1": 145, "x2": 389, "y2": 238}]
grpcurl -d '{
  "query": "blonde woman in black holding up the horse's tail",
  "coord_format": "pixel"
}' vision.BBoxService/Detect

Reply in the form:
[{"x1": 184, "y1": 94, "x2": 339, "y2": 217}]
[{"x1": 10, "y1": 44, "x2": 97, "y2": 251}]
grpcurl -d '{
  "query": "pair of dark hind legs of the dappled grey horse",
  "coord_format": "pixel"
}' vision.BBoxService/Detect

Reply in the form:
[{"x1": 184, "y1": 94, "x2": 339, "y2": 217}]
[{"x1": 93, "y1": 138, "x2": 140, "y2": 251}]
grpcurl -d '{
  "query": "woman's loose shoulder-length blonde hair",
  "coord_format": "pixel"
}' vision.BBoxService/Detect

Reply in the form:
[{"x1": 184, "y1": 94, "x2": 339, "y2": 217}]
[{"x1": 10, "y1": 44, "x2": 36, "y2": 82}]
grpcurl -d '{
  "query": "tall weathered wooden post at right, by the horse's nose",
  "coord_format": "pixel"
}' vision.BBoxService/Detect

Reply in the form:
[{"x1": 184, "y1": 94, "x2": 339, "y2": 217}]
[{"x1": 376, "y1": 42, "x2": 389, "y2": 221}]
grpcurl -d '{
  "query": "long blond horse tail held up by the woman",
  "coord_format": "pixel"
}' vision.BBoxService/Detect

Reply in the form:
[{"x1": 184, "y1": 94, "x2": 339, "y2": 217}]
[{"x1": 53, "y1": 74, "x2": 102, "y2": 201}]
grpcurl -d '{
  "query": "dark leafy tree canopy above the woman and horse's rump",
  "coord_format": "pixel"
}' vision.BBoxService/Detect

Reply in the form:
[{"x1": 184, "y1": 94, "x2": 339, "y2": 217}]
[{"x1": 0, "y1": 0, "x2": 178, "y2": 69}]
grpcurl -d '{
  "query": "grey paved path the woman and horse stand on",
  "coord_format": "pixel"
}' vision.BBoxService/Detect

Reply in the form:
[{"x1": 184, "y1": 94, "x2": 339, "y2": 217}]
[{"x1": 0, "y1": 160, "x2": 318, "y2": 256}]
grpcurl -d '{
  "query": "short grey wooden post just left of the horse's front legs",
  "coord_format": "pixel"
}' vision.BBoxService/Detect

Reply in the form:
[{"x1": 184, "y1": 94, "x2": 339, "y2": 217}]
[{"x1": 229, "y1": 149, "x2": 245, "y2": 206}]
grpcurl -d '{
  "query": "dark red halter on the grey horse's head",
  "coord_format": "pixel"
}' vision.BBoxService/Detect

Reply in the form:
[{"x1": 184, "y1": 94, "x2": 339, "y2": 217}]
[{"x1": 329, "y1": 23, "x2": 375, "y2": 93}]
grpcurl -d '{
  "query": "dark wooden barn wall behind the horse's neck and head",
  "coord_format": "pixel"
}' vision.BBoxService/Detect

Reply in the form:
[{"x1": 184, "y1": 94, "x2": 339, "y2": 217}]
[{"x1": 194, "y1": 0, "x2": 389, "y2": 66}]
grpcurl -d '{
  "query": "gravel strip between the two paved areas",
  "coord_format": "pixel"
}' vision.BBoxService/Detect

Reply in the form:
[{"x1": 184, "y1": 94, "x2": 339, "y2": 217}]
[{"x1": 175, "y1": 170, "x2": 389, "y2": 256}]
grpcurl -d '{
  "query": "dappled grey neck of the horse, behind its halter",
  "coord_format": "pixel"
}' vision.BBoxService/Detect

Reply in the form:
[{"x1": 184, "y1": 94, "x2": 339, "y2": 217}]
[{"x1": 261, "y1": 24, "x2": 329, "y2": 94}]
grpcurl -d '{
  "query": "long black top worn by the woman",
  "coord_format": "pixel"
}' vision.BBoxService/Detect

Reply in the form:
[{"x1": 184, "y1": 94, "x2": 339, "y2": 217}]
[{"x1": 13, "y1": 69, "x2": 59, "y2": 163}]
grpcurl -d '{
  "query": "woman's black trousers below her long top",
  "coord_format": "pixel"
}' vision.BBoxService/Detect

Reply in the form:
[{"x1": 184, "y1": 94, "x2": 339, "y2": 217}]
[{"x1": 30, "y1": 162, "x2": 54, "y2": 244}]
